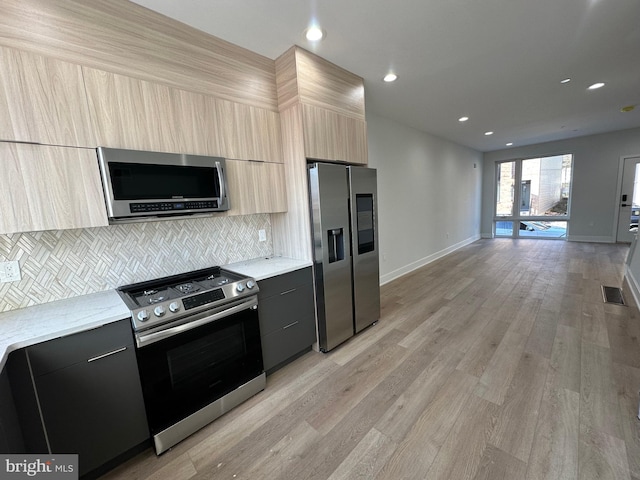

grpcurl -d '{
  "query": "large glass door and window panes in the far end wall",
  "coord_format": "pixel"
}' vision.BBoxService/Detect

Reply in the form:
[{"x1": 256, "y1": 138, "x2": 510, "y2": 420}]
[{"x1": 494, "y1": 154, "x2": 573, "y2": 239}]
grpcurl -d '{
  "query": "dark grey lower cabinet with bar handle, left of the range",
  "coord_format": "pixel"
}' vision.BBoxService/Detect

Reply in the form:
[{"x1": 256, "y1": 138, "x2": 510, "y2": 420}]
[{"x1": 14, "y1": 320, "x2": 149, "y2": 476}]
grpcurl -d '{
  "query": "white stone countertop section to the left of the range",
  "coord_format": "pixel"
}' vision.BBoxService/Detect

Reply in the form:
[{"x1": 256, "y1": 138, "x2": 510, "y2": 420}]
[{"x1": 0, "y1": 290, "x2": 131, "y2": 370}]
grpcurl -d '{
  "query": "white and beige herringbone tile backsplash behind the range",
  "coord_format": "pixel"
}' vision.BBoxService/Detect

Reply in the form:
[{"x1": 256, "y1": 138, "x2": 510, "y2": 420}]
[{"x1": 0, "y1": 214, "x2": 273, "y2": 312}]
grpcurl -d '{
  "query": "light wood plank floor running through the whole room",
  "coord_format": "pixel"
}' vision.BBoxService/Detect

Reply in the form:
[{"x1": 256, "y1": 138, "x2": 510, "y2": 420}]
[{"x1": 104, "y1": 239, "x2": 640, "y2": 480}]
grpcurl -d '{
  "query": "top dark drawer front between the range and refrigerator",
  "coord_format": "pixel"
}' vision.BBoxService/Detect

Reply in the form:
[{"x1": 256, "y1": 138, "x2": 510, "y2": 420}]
[{"x1": 258, "y1": 283, "x2": 314, "y2": 336}]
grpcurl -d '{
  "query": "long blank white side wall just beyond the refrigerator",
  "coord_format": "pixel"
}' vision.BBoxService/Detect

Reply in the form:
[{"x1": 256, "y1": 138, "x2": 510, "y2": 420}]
[{"x1": 367, "y1": 113, "x2": 482, "y2": 283}]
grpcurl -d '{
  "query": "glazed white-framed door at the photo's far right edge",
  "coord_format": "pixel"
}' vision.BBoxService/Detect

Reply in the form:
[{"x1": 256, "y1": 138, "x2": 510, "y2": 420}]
[{"x1": 616, "y1": 156, "x2": 640, "y2": 243}]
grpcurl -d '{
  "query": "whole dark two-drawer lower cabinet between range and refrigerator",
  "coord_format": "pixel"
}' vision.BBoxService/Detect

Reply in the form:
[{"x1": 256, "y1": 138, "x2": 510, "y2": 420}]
[{"x1": 258, "y1": 267, "x2": 316, "y2": 374}]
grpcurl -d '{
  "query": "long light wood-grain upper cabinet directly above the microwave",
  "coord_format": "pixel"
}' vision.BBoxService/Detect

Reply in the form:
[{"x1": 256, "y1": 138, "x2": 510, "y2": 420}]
[{"x1": 83, "y1": 67, "x2": 282, "y2": 163}]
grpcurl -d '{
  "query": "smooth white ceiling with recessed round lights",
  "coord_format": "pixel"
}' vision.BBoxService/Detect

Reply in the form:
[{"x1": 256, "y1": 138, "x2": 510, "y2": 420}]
[{"x1": 130, "y1": 0, "x2": 640, "y2": 152}]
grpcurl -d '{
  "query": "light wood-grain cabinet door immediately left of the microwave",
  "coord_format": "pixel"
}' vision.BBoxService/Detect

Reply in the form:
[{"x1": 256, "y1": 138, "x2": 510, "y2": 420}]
[{"x1": 0, "y1": 142, "x2": 108, "y2": 234}]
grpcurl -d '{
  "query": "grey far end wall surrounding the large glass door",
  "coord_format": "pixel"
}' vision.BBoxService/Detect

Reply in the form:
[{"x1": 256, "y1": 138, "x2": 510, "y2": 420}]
[{"x1": 482, "y1": 128, "x2": 640, "y2": 242}]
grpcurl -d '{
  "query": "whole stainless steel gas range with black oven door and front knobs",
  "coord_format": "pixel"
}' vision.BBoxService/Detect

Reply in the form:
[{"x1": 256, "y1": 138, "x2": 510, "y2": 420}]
[{"x1": 118, "y1": 267, "x2": 266, "y2": 454}]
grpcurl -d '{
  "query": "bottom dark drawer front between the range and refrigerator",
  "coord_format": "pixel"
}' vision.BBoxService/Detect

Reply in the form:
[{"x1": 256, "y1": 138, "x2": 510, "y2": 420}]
[{"x1": 262, "y1": 317, "x2": 316, "y2": 370}]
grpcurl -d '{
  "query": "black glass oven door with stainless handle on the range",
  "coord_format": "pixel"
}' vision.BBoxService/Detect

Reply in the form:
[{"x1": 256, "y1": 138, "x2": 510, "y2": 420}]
[{"x1": 136, "y1": 298, "x2": 263, "y2": 434}]
